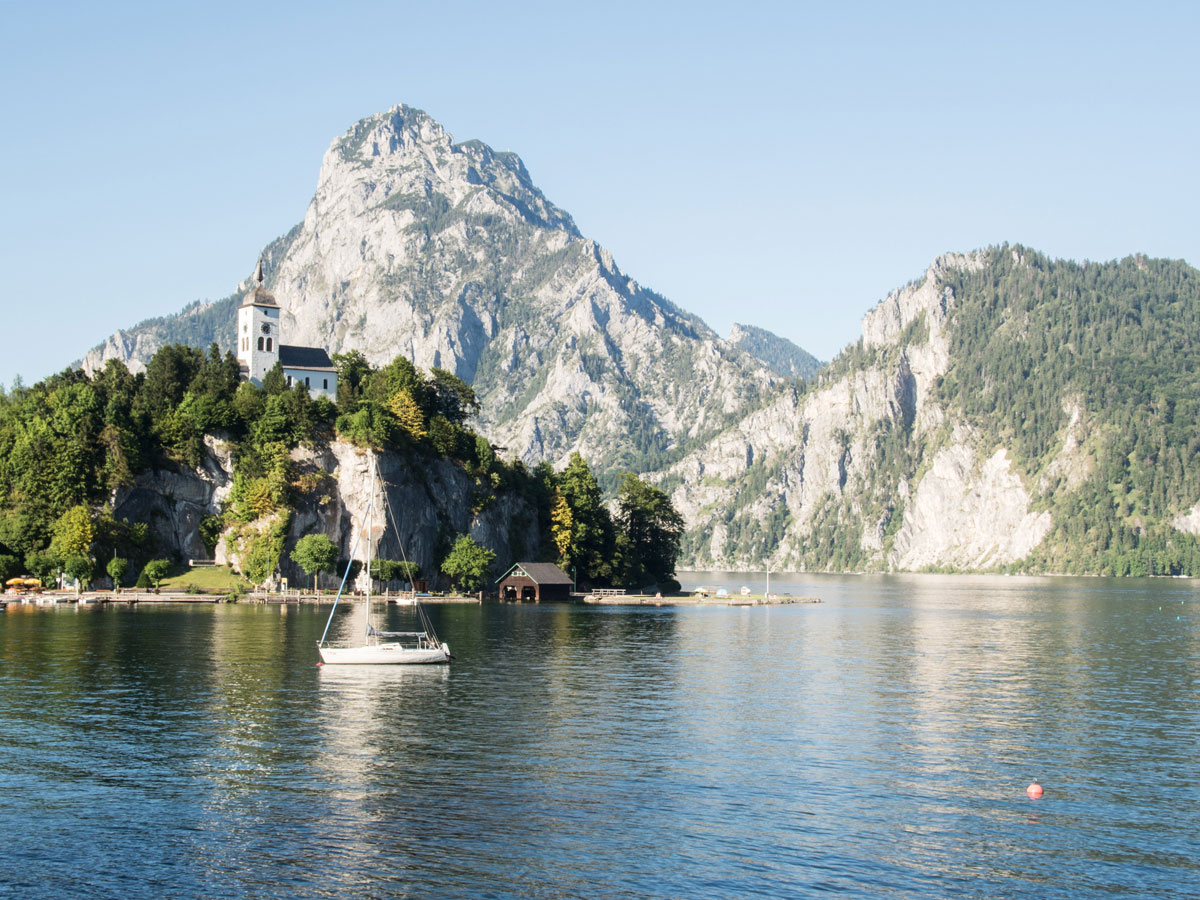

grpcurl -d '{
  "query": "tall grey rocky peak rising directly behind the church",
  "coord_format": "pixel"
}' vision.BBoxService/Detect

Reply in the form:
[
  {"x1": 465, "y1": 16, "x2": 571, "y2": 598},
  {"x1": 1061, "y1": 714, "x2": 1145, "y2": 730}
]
[{"x1": 83, "y1": 107, "x2": 796, "y2": 486}]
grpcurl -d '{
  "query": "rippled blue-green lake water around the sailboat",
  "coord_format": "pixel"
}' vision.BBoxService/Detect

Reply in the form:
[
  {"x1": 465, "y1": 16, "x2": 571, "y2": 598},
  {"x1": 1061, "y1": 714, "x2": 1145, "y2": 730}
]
[{"x1": 0, "y1": 572, "x2": 1200, "y2": 900}]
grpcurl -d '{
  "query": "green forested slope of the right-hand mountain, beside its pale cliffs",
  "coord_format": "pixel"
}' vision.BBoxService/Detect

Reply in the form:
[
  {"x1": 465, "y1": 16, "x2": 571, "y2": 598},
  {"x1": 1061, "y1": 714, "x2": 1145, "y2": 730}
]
[{"x1": 940, "y1": 248, "x2": 1200, "y2": 574}]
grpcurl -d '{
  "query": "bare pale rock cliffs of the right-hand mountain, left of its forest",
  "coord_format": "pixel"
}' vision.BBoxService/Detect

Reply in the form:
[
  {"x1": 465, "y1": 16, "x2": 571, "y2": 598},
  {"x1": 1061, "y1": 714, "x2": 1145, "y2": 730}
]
[{"x1": 661, "y1": 254, "x2": 1050, "y2": 570}]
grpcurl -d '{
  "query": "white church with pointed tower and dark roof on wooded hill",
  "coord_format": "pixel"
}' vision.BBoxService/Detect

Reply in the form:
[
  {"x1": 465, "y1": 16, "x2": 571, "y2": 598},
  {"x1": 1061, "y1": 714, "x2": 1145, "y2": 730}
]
[{"x1": 238, "y1": 259, "x2": 337, "y2": 401}]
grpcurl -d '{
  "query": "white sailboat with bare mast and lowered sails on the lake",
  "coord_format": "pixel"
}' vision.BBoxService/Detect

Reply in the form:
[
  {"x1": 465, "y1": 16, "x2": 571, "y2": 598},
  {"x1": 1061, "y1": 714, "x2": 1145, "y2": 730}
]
[{"x1": 317, "y1": 455, "x2": 451, "y2": 666}]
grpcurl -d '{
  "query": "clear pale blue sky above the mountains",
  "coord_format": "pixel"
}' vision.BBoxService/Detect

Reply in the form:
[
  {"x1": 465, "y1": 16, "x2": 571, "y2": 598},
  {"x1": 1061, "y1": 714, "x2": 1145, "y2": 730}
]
[{"x1": 0, "y1": 0, "x2": 1200, "y2": 385}]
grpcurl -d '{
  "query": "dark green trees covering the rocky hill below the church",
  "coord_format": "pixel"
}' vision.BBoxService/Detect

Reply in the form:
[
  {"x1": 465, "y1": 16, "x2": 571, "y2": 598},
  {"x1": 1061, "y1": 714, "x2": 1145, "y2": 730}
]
[{"x1": 0, "y1": 344, "x2": 682, "y2": 586}]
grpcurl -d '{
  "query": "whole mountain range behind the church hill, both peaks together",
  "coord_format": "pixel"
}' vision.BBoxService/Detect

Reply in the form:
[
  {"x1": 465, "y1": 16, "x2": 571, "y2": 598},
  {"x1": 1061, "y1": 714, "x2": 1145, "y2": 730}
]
[{"x1": 72, "y1": 107, "x2": 1200, "y2": 574}]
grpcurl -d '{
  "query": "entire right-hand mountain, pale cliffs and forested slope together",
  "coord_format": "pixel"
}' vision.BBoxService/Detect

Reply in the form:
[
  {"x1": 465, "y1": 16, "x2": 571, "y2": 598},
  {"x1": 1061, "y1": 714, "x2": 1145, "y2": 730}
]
[{"x1": 659, "y1": 246, "x2": 1200, "y2": 575}]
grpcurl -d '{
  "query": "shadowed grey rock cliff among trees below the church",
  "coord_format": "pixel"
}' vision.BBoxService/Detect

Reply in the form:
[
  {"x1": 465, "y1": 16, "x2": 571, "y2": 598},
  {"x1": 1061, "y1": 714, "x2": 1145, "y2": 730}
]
[{"x1": 113, "y1": 438, "x2": 539, "y2": 587}]
